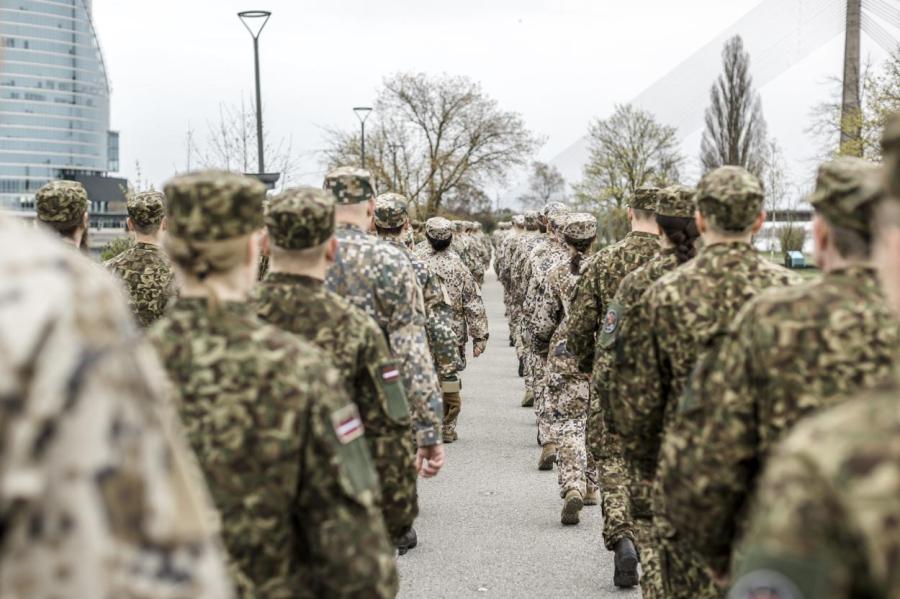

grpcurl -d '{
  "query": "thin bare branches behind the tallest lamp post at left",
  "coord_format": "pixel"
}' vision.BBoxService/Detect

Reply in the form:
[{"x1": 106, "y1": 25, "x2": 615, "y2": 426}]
[{"x1": 185, "y1": 99, "x2": 299, "y2": 189}]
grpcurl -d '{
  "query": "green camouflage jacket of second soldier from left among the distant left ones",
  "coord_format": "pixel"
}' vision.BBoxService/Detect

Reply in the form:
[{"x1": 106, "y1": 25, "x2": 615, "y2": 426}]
[{"x1": 103, "y1": 243, "x2": 178, "y2": 327}]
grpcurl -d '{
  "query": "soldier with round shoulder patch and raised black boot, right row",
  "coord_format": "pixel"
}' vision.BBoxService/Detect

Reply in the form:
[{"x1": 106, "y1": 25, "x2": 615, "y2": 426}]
[{"x1": 568, "y1": 187, "x2": 659, "y2": 587}]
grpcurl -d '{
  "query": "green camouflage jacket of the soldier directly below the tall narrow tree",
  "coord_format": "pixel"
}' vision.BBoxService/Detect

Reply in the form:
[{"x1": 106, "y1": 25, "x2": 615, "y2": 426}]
[{"x1": 615, "y1": 242, "x2": 799, "y2": 479}]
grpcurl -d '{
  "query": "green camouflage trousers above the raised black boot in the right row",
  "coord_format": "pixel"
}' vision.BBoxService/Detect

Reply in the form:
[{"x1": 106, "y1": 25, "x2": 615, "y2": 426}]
[{"x1": 587, "y1": 384, "x2": 635, "y2": 551}]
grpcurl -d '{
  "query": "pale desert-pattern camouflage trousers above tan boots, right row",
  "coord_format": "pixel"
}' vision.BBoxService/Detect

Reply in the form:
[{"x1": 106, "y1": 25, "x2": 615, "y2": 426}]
[{"x1": 544, "y1": 372, "x2": 598, "y2": 497}]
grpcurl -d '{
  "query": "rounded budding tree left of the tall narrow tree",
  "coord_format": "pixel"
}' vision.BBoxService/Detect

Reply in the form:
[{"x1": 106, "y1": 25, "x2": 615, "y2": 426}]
[{"x1": 574, "y1": 104, "x2": 684, "y2": 242}]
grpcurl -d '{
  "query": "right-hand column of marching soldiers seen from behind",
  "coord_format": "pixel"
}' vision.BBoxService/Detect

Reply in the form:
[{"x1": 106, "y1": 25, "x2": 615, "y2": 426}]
[{"x1": 494, "y1": 139, "x2": 900, "y2": 599}]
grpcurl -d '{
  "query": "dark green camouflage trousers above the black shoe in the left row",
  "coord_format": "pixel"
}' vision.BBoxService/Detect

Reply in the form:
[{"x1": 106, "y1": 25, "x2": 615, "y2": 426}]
[{"x1": 366, "y1": 435, "x2": 419, "y2": 540}]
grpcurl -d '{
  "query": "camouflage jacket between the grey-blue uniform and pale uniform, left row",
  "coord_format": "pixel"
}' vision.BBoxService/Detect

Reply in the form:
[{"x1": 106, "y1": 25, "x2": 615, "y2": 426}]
[{"x1": 386, "y1": 240, "x2": 461, "y2": 377}]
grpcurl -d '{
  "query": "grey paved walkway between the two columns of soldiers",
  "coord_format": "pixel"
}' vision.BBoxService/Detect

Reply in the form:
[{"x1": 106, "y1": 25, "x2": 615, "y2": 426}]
[{"x1": 399, "y1": 272, "x2": 640, "y2": 599}]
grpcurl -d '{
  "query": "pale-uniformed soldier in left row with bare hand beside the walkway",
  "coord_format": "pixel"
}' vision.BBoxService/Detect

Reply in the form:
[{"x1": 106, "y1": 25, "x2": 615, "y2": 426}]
[{"x1": 419, "y1": 217, "x2": 488, "y2": 441}]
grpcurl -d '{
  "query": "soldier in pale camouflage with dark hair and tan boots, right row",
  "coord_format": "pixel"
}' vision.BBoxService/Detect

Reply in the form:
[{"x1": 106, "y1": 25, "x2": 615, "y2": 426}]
[{"x1": 531, "y1": 214, "x2": 597, "y2": 525}]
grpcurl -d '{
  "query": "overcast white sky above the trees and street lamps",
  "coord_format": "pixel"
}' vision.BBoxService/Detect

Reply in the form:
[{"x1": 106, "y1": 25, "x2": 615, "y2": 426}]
[{"x1": 94, "y1": 0, "x2": 884, "y2": 204}]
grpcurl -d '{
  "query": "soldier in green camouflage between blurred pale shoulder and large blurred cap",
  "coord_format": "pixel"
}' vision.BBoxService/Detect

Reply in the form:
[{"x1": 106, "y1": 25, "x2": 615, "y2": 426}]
[{"x1": 104, "y1": 191, "x2": 177, "y2": 327}]
